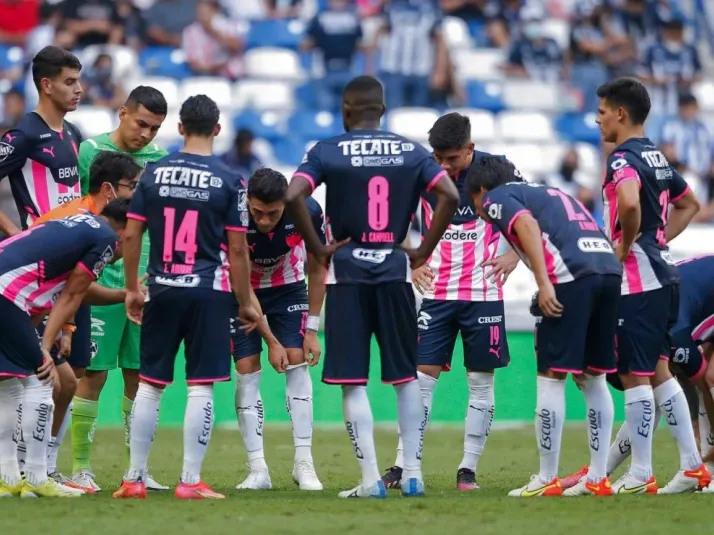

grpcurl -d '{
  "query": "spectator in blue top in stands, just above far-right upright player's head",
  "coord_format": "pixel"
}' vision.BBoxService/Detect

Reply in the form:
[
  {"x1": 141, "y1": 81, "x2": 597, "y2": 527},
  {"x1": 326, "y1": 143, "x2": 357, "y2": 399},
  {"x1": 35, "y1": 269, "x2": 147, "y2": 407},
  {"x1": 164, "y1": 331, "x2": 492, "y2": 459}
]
[{"x1": 638, "y1": 19, "x2": 702, "y2": 115}]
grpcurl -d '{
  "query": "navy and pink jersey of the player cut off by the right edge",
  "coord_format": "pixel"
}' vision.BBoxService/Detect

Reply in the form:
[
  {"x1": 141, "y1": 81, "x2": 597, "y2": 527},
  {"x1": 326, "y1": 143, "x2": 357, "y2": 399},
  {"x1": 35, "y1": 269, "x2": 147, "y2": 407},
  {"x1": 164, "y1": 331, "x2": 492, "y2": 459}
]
[{"x1": 672, "y1": 255, "x2": 714, "y2": 342}]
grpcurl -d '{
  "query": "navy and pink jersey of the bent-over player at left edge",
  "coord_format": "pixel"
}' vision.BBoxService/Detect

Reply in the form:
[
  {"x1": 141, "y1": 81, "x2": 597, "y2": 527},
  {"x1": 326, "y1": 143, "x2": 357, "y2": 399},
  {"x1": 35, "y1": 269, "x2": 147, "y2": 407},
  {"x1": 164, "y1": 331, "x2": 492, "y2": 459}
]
[{"x1": 0, "y1": 214, "x2": 119, "y2": 315}]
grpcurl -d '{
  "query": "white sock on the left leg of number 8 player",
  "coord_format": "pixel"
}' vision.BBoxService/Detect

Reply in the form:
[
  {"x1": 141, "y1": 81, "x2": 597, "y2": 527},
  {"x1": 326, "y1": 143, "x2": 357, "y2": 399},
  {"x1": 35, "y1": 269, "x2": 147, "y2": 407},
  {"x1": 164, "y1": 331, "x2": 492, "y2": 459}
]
[{"x1": 342, "y1": 386, "x2": 381, "y2": 488}]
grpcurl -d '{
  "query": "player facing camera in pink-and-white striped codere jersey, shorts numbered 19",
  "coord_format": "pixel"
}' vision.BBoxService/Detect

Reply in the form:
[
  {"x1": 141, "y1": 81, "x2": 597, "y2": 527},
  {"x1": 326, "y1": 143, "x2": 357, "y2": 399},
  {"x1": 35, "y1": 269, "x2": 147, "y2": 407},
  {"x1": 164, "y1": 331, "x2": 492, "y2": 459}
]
[{"x1": 382, "y1": 113, "x2": 518, "y2": 490}]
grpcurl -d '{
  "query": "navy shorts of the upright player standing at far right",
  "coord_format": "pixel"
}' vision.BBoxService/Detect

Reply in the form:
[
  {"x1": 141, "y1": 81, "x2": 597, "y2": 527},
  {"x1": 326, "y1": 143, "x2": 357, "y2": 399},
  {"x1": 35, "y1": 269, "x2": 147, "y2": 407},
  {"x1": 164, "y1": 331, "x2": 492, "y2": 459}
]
[{"x1": 617, "y1": 284, "x2": 679, "y2": 376}]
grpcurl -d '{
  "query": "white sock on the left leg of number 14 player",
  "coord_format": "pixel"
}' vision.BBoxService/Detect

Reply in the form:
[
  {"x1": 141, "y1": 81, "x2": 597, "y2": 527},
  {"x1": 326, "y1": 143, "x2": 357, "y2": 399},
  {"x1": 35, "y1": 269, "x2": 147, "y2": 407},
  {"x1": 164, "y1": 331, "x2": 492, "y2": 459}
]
[{"x1": 124, "y1": 383, "x2": 163, "y2": 481}]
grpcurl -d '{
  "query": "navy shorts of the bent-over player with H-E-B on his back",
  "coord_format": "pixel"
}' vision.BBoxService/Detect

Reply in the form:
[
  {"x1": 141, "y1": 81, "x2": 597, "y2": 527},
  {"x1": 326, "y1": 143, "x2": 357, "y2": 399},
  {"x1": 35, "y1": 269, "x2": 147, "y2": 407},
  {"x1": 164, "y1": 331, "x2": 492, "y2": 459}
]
[{"x1": 535, "y1": 275, "x2": 622, "y2": 373}]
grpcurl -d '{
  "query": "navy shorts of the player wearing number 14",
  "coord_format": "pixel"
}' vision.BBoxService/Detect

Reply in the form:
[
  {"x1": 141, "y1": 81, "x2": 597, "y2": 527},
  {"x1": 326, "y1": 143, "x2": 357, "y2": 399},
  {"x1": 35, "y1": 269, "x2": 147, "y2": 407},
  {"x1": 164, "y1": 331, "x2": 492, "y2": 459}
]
[{"x1": 139, "y1": 285, "x2": 234, "y2": 385}]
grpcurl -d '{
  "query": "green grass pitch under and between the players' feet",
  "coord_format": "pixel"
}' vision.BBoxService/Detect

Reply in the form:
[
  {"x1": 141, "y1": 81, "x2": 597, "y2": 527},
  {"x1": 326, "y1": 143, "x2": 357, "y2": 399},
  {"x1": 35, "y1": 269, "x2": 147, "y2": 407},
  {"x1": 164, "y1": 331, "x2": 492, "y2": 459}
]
[{"x1": 0, "y1": 428, "x2": 714, "y2": 535}]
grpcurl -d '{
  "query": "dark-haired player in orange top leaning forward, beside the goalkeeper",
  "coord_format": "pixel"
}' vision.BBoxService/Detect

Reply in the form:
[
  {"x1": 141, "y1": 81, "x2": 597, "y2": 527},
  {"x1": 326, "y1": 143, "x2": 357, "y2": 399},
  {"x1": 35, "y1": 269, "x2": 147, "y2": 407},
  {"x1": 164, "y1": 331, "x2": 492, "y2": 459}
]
[{"x1": 34, "y1": 152, "x2": 141, "y2": 486}]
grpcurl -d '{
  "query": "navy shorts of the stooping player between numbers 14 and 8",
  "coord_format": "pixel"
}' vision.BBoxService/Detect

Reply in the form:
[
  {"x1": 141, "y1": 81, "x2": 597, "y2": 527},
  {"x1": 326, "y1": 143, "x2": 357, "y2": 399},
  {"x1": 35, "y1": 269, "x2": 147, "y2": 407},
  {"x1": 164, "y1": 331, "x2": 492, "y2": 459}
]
[{"x1": 231, "y1": 282, "x2": 308, "y2": 360}]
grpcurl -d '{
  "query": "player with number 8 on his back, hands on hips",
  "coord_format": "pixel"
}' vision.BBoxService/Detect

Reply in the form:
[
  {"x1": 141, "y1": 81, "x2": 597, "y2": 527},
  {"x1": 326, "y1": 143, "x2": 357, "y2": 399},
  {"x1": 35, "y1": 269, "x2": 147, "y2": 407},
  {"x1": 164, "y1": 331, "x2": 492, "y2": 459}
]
[{"x1": 286, "y1": 76, "x2": 459, "y2": 498}]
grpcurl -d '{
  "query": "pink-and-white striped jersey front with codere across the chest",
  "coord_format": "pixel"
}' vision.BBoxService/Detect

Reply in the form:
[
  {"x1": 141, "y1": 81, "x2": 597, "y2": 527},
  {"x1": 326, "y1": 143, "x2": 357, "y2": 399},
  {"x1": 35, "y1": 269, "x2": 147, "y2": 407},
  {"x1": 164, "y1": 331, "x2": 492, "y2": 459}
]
[{"x1": 421, "y1": 151, "x2": 508, "y2": 301}]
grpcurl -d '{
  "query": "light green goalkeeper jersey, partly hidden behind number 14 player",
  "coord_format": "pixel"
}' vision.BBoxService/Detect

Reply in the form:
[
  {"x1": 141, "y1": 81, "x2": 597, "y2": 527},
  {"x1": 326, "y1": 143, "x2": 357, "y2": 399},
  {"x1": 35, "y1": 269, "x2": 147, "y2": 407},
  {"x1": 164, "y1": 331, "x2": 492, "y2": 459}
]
[{"x1": 78, "y1": 134, "x2": 168, "y2": 288}]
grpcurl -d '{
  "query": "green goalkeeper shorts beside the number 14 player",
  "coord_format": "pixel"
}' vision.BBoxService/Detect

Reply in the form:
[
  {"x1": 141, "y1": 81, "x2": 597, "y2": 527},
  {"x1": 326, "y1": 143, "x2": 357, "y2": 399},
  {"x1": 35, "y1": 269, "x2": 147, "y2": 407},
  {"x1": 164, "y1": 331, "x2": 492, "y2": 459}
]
[{"x1": 87, "y1": 303, "x2": 141, "y2": 372}]
